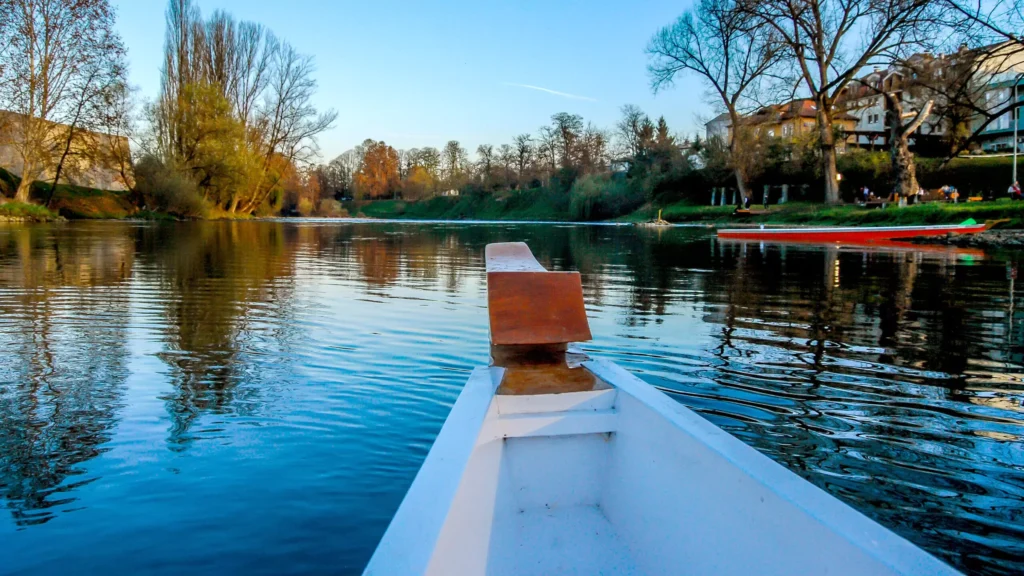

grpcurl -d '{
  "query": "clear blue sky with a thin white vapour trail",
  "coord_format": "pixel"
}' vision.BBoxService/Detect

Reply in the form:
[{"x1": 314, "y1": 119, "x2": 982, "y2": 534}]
[{"x1": 113, "y1": 0, "x2": 710, "y2": 160}]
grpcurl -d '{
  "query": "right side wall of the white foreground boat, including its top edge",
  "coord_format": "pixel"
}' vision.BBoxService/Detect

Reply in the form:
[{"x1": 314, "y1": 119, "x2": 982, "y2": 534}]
[{"x1": 586, "y1": 361, "x2": 956, "y2": 575}]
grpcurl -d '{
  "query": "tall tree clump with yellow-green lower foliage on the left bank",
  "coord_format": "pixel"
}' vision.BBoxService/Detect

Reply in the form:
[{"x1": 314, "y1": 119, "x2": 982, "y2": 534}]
[{"x1": 151, "y1": 0, "x2": 337, "y2": 213}]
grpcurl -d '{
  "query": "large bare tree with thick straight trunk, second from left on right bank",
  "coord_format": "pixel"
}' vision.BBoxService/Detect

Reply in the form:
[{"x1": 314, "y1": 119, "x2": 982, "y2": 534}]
[{"x1": 738, "y1": 0, "x2": 940, "y2": 203}]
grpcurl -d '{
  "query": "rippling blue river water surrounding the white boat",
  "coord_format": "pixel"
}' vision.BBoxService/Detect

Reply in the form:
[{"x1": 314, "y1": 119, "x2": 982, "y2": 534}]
[{"x1": 0, "y1": 221, "x2": 1024, "y2": 574}]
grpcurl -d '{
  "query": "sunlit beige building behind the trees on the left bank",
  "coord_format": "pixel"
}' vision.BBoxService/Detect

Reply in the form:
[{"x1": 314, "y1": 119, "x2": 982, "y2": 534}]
[{"x1": 0, "y1": 111, "x2": 132, "y2": 191}]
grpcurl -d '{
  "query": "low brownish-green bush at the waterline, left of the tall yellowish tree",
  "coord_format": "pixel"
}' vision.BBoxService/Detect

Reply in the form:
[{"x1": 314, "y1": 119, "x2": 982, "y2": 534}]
[{"x1": 135, "y1": 155, "x2": 209, "y2": 218}]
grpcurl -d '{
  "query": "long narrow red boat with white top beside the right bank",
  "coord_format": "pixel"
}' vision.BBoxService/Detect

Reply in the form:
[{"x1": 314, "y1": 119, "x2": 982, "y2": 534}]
[{"x1": 718, "y1": 217, "x2": 987, "y2": 243}]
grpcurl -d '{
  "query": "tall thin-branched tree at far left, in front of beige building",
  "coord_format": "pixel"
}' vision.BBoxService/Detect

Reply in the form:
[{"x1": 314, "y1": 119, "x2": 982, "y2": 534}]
[{"x1": 0, "y1": 0, "x2": 124, "y2": 202}]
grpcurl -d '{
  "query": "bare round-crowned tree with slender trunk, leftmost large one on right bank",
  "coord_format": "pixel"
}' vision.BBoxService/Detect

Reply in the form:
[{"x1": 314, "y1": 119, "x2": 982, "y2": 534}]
[{"x1": 647, "y1": 0, "x2": 783, "y2": 198}]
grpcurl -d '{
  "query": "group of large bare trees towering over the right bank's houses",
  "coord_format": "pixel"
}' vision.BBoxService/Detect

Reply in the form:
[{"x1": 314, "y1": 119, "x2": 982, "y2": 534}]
[{"x1": 647, "y1": 0, "x2": 1024, "y2": 203}]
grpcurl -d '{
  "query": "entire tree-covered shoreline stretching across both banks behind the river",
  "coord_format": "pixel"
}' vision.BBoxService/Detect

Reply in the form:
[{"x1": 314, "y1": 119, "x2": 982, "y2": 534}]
[{"x1": 6, "y1": 0, "x2": 1024, "y2": 227}]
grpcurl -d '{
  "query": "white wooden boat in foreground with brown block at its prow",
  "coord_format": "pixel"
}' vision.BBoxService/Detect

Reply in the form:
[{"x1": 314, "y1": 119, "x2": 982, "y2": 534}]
[{"x1": 365, "y1": 244, "x2": 956, "y2": 576}]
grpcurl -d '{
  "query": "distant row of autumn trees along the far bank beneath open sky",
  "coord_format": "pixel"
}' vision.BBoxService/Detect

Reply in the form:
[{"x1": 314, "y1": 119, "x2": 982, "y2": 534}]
[{"x1": 309, "y1": 105, "x2": 684, "y2": 212}]
